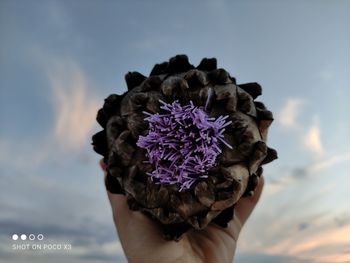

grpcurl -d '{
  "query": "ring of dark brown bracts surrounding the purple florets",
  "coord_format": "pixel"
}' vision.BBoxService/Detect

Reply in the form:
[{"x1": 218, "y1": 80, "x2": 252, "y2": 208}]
[{"x1": 92, "y1": 55, "x2": 277, "y2": 240}]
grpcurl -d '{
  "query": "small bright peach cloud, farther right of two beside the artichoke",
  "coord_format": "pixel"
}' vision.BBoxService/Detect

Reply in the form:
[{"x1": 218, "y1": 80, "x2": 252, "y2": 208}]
[{"x1": 303, "y1": 117, "x2": 324, "y2": 156}]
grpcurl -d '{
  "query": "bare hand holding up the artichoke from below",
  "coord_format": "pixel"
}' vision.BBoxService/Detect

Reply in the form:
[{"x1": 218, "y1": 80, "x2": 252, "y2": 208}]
[{"x1": 100, "y1": 161, "x2": 264, "y2": 263}]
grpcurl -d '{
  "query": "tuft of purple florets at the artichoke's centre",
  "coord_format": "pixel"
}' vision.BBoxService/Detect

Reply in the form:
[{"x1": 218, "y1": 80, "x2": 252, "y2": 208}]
[{"x1": 137, "y1": 100, "x2": 232, "y2": 191}]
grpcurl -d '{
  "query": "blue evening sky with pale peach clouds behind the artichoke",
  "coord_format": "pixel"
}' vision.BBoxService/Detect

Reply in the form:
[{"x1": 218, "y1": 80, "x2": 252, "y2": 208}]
[{"x1": 0, "y1": 0, "x2": 350, "y2": 263}]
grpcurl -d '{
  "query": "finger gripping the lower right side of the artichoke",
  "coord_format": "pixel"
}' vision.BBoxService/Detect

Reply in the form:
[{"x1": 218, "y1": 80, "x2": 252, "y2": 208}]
[{"x1": 235, "y1": 176, "x2": 264, "y2": 226}]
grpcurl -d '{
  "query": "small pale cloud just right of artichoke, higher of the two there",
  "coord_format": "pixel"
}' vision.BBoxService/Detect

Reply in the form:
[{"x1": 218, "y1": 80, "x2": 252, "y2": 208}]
[{"x1": 277, "y1": 98, "x2": 304, "y2": 129}]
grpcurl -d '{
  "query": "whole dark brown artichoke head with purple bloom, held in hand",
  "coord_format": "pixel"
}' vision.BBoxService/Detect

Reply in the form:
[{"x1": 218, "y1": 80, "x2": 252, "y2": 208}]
[{"x1": 92, "y1": 55, "x2": 277, "y2": 240}]
